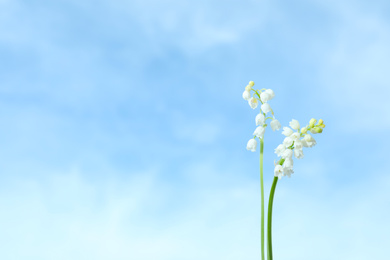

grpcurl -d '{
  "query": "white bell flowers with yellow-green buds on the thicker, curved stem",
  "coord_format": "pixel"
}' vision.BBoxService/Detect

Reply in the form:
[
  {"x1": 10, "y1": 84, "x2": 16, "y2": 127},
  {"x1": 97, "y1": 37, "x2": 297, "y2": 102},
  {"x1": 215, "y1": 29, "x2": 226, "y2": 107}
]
[{"x1": 274, "y1": 118, "x2": 325, "y2": 179}]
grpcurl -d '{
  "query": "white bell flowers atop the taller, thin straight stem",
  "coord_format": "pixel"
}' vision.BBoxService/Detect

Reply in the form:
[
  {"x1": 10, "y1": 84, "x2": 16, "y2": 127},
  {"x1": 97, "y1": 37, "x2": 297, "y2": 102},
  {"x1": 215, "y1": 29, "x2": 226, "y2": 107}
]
[{"x1": 242, "y1": 81, "x2": 282, "y2": 152}]
